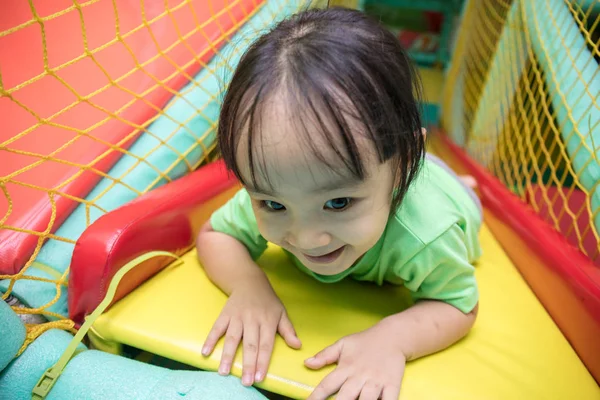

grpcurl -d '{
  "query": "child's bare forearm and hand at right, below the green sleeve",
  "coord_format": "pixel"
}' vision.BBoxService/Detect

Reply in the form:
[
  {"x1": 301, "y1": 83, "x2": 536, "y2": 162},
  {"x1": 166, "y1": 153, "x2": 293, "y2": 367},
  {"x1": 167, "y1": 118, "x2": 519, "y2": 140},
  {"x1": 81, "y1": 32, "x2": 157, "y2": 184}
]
[{"x1": 305, "y1": 300, "x2": 477, "y2": 400}]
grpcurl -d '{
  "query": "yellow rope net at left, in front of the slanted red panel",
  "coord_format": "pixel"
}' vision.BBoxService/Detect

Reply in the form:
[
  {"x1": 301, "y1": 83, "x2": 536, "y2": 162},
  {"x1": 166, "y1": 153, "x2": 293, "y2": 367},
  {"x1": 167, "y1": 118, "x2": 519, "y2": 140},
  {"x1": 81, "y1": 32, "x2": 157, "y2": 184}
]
[{"x1": 0, "y1": 0, "x2": 346, "y2": 351}]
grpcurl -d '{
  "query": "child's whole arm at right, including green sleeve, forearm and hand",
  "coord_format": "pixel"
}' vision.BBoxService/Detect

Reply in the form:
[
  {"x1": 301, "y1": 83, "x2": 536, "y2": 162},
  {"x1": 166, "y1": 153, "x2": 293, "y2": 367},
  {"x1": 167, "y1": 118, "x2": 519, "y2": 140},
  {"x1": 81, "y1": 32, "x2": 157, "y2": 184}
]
[{"x1": 306, "y1": 226, "x2": 479, "y2": 400}]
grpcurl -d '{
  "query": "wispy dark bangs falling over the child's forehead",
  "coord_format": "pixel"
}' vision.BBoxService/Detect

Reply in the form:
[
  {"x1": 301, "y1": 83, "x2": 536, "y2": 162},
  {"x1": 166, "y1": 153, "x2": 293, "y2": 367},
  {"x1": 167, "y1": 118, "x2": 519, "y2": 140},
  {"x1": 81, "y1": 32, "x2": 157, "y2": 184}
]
[{"x1": 229, "y1": 79, "x2": 376, "y2": 191}]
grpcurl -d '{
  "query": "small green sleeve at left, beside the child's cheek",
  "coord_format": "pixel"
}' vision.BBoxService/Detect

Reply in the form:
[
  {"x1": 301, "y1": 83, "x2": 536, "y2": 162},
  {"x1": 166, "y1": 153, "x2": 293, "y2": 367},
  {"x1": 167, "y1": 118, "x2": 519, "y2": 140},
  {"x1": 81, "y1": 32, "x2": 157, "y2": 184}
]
[{"x1": 210, "y1": 189, "x2": 267, "y2": 260}]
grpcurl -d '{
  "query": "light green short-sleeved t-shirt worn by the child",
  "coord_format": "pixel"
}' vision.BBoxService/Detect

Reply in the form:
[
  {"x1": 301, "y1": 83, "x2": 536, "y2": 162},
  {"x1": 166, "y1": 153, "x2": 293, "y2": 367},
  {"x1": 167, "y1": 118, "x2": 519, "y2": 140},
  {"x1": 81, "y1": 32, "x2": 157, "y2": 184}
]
[{"x1": 210, "y1": 160, "x2": 481, "y2": 313}]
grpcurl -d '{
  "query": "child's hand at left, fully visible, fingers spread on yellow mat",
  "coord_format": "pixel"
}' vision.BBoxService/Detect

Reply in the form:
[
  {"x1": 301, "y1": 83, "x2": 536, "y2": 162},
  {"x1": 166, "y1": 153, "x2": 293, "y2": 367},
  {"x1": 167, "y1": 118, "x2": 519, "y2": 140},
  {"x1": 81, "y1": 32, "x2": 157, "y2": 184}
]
[{"x1": 202, "y1": 277, "x2": 302, "y2": 386}]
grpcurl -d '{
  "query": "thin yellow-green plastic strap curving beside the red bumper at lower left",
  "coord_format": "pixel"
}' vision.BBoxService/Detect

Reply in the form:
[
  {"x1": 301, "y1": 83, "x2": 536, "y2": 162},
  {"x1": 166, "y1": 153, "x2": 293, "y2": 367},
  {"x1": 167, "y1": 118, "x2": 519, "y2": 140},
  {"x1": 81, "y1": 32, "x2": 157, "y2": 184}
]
[{"x1": 31, "y1": 251, "x2": 179, "y2": 400}]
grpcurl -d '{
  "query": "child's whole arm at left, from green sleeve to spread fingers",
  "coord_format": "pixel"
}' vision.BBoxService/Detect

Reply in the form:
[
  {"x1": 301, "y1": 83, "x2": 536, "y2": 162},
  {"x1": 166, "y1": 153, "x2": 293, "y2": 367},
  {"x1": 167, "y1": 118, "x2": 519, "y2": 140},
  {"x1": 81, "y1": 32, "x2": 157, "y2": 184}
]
[{"x1": 196, "y1": 191, "x2": 301, "y2": 385}]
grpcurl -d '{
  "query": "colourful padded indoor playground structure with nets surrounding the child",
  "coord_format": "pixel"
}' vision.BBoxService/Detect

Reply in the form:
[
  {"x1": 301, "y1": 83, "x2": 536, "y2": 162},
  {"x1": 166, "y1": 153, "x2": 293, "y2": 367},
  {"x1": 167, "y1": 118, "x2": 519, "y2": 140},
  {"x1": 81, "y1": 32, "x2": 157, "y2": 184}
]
[{"x1": 0, "y1": 0, "x2": 600, "y2": 400}]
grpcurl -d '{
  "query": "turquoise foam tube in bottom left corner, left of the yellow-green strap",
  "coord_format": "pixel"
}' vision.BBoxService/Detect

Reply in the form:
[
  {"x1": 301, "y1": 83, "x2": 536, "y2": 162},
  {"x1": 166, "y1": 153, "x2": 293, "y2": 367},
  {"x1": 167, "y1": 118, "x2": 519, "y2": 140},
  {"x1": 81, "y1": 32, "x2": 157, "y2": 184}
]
[{"x1": 0, "y1": 329, "x2": 85, "y2": 400}]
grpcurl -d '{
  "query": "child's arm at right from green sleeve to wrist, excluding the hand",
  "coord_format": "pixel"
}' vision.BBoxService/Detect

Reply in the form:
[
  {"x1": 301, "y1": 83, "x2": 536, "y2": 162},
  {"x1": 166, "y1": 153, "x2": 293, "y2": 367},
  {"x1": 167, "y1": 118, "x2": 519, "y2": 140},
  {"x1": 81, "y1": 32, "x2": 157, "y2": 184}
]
[{"x1": 380, "y1": 225, "x2": 479, "y2": 360}]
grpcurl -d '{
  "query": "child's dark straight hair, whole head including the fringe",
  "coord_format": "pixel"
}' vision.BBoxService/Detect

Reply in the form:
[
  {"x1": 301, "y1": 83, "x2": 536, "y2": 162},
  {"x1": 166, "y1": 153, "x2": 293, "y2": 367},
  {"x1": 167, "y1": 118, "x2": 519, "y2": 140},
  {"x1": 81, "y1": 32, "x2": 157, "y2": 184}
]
[{"x1": 217, "y1": 8, "x2": 425, "y2": 211}]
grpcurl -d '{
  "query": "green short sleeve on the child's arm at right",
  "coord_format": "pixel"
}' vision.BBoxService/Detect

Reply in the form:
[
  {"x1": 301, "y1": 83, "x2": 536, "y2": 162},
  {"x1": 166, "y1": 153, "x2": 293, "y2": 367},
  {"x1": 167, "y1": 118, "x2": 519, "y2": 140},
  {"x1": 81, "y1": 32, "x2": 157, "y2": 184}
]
[{"x1": 393, "y1": 224, "x2": 479, "y2": 314}]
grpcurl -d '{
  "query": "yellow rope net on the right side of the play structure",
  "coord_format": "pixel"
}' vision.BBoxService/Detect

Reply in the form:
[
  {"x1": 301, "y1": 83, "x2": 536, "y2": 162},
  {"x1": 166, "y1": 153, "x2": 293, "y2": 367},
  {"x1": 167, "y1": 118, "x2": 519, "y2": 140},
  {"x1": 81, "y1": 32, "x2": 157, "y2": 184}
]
[{"x1": 442, "y1": 0, "x2": 600, "y2": 265}]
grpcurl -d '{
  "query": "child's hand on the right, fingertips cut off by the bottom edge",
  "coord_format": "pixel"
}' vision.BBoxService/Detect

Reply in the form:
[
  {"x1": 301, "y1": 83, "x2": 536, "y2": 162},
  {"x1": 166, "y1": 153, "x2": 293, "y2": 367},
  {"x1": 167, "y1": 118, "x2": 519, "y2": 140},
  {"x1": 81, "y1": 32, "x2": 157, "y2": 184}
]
[{"x1": 304, "y1": 324, "x2": 406, "y2": 400}]
